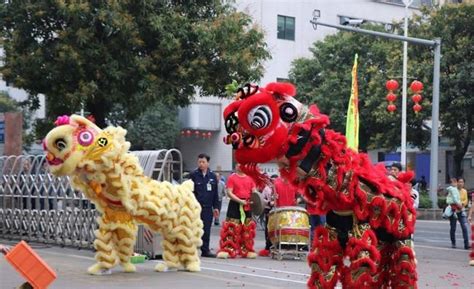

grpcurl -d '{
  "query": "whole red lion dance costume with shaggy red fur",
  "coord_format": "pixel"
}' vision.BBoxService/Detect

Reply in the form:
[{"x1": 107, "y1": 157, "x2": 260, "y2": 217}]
[{"x1": 224, "y1": 83, "x2": 417, "y2": 288}]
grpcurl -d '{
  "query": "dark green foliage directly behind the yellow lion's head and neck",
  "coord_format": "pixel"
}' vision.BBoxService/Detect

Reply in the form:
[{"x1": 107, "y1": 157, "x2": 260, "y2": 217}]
[{"x1": 127, "y1": 103, "x2": 179, "y2": 150}]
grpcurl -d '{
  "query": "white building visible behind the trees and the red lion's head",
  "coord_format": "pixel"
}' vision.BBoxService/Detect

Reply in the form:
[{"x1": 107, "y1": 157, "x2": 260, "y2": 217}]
[{"x1": 178, "y1": 0, "x2": 431, "y2": 173}]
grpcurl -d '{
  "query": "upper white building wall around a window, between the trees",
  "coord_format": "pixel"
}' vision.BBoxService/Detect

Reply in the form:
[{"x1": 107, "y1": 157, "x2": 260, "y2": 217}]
[{"x1": 237, "y1": 0, "x2": 418, "y2": 84}]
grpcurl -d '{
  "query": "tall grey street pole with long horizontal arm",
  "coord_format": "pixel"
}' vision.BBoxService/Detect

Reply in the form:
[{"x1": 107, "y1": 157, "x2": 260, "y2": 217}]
[{"x1": 310, "y1": 13, "x2": 441, "y2": 208}]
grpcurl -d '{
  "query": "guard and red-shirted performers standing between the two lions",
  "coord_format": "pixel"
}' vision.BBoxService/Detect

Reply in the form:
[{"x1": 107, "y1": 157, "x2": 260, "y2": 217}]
[{"x1": 190, "y1": 154, "x2": 325, "y2": 258}]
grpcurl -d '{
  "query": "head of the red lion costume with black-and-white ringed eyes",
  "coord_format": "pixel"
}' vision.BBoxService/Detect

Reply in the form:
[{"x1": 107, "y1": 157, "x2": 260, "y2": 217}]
[{"x1": 224, "y1": 83, "x2": 301, "y2": 164}]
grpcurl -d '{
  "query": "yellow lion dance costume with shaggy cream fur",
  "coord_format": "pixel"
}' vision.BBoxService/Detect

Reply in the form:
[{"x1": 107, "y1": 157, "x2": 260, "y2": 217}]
[{"x1": 43, "y1": 115, "x2": 203, "y2": 275}]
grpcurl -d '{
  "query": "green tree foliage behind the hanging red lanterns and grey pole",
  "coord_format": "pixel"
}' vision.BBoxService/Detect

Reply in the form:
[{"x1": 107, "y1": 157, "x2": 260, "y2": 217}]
[{"x1": 290, "y1": 4, "x2": 474, "y2": 175}]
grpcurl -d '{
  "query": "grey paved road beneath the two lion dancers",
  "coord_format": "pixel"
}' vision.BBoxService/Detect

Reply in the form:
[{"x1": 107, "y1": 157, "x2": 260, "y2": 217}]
[{"x1": 0, "y1": 210, "x2": 474, "y2": 289}]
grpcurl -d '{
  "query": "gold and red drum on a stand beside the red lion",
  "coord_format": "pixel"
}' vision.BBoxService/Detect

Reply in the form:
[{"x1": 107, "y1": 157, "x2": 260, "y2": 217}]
[{"x1": 268, "y1": 207, "x2": 310, "y2": 246}]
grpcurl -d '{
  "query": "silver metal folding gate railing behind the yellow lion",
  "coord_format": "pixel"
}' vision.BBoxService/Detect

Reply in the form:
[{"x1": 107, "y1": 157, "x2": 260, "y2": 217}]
[{"x1": 0, "y1": 149, "x2": 182, "y2": 248}]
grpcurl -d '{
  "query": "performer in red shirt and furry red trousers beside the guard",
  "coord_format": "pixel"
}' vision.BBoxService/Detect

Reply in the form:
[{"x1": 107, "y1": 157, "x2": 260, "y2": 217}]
[{"x1": 217, "y1": 164, "x2": 258, "y2": 259}]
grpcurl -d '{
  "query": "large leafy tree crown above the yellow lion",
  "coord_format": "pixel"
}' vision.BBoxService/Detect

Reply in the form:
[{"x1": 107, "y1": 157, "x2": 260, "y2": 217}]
[{"x1": 0, "y1": 0, "x2": 269, "y2": 126}]
